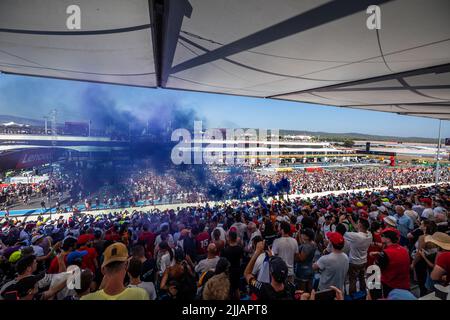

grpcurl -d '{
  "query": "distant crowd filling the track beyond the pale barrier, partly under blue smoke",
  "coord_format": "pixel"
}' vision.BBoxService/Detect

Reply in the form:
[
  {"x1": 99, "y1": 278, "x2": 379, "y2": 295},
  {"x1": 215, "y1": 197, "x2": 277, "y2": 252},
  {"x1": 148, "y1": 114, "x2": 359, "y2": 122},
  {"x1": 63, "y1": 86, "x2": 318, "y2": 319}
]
[{"x1": 0, "y1": 167, "x2": 450, "y2": 212}]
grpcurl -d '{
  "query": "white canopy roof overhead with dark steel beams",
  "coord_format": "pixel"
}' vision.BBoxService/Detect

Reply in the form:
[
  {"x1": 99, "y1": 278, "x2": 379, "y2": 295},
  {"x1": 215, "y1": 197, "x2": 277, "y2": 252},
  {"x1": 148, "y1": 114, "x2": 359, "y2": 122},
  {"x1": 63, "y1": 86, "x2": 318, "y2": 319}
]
[{"x1": 0, "y1": 0, "x2": 450, "y2": 119}]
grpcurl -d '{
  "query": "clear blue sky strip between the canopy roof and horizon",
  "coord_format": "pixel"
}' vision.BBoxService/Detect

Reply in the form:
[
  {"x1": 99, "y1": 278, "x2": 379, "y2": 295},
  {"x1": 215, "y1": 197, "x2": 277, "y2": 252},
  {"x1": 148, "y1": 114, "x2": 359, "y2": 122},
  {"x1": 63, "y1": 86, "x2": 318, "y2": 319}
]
[{"x1": 0, "y1": 74, "x2": 450, "y2": 138}]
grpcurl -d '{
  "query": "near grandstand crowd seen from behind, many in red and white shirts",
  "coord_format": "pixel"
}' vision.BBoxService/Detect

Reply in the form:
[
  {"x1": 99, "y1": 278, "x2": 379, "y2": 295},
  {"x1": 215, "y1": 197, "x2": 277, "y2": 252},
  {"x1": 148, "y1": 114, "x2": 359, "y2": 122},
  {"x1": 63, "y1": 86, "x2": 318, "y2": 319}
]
[{"x1": 0, "y1": 180, "x2": 450, "y2": 300}]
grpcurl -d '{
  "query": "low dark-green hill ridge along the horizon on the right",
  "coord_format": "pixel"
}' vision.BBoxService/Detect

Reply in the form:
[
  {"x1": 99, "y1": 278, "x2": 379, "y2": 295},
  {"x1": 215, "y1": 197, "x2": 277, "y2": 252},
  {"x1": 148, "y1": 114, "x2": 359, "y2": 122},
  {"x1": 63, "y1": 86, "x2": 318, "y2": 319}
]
[{"x1": 280, "y1": 130, "x2": 438, "y2": 143}]
